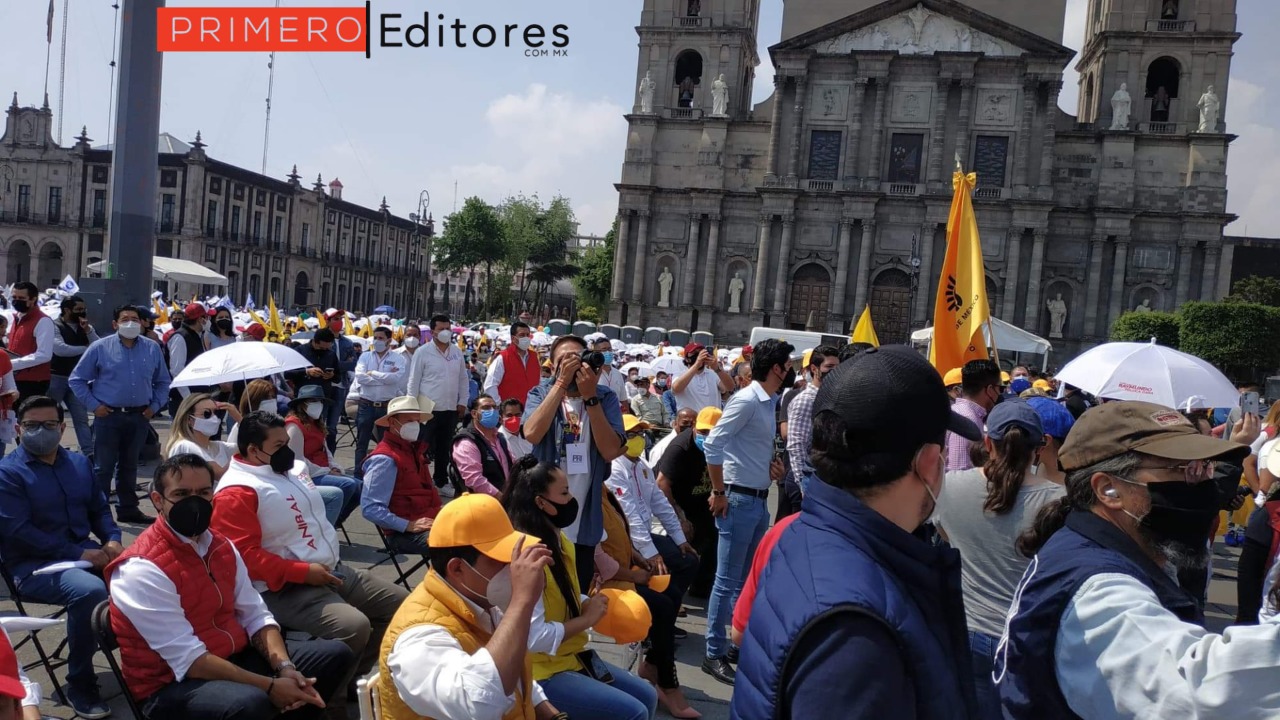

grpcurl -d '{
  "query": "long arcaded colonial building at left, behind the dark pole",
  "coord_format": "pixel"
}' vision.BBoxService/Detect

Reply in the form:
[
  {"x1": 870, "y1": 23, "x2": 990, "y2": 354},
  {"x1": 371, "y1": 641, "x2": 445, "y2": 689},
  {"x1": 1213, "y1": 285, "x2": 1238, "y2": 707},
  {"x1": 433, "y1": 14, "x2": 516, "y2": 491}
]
[{"x1": 0, "y1": 94, "x2": 433, "y2": 314}]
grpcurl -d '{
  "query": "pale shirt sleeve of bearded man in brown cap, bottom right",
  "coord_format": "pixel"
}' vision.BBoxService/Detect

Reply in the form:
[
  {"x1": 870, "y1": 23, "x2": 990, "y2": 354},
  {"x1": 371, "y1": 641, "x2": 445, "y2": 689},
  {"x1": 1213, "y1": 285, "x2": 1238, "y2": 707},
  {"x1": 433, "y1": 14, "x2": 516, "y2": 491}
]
[{"x1": 1044, "y1": 561, "x2": 1280, "y2": 720}]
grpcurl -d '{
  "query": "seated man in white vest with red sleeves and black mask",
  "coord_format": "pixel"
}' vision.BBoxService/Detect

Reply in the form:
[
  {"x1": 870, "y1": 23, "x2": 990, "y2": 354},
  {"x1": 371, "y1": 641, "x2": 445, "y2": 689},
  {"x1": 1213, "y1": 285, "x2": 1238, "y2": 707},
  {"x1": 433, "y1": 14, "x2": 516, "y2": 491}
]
[{"x1": 212, "y1": 411, "x2": 408, "y2": 705}]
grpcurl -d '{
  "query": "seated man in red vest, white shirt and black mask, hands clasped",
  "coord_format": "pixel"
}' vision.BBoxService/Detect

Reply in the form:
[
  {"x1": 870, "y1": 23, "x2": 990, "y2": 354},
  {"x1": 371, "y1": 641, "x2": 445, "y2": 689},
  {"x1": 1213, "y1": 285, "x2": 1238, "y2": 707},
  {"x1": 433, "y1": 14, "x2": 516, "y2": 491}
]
[{"x1": 106, "y1": 454, "x2": 356, "y2": 720}]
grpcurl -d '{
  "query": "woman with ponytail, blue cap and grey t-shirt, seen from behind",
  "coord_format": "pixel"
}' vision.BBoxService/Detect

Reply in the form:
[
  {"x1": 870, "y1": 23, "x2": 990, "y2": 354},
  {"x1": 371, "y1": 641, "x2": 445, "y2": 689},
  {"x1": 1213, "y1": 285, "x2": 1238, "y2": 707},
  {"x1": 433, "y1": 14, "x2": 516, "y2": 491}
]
[{"x1": 934, "y1": 400, "x2": 1066, "y2": 719}]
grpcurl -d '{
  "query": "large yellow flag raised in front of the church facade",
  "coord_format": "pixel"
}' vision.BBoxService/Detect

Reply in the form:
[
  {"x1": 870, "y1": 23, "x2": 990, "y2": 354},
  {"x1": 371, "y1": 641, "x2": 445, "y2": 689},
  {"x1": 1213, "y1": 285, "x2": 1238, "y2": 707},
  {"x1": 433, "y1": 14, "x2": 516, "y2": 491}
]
[{"x1": 929, "y1": 172, "x2": 991, "y2": 373}]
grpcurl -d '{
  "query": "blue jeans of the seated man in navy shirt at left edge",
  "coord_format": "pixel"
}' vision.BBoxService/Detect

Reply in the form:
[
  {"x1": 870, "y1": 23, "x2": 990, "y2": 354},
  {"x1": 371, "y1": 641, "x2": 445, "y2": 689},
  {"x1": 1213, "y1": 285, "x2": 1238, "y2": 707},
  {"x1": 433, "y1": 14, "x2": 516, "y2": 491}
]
[{"x1": 18, "y1": 569, "x2": 106, "y2": 689}]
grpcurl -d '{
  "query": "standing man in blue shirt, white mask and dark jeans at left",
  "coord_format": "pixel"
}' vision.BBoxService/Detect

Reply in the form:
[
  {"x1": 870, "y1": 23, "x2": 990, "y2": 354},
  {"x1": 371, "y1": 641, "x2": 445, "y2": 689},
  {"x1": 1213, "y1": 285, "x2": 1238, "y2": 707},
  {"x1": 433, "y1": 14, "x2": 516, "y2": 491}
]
[{"x1": 70, "y1": 305, "x2": 169, "y2": 525}]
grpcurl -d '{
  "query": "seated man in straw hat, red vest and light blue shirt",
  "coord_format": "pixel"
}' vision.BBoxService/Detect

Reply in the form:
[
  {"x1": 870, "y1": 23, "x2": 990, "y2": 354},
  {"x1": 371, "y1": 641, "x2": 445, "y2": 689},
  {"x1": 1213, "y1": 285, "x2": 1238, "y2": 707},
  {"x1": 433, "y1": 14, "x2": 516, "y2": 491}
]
[{"x1": 360, "y1": 396, "x2": 440, "y2": 555}]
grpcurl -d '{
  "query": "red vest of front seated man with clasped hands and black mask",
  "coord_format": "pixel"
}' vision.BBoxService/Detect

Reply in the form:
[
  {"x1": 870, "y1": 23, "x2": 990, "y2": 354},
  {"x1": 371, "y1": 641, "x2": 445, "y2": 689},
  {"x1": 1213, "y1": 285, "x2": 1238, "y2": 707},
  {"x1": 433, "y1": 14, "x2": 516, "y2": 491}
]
[{"x1": 105, "y1": 520, "x2": 248, "y2": 701}]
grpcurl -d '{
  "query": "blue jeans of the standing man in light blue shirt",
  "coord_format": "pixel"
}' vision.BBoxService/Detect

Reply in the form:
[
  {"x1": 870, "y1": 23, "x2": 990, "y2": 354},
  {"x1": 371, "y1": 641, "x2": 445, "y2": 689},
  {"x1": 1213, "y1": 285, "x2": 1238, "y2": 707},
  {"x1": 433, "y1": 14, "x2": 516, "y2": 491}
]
[{"x1": 707, "y1": 492, "x2": 769, "y2": 657}]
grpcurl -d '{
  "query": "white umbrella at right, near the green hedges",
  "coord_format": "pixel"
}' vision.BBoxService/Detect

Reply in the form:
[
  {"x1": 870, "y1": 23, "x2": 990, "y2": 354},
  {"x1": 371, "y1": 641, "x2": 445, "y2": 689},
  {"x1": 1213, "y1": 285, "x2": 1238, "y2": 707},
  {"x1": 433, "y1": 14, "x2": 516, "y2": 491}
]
[{"x1": 1057, "y1": 340, "x2": 1240, "y2": 409}]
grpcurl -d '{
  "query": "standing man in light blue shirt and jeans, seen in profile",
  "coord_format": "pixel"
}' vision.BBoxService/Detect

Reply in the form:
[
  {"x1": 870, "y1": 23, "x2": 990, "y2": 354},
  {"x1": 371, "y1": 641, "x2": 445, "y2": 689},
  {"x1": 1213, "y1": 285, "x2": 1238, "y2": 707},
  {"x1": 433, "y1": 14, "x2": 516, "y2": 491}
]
[{"x1": 703, "y1": 340, "x2": 796, "y2": 685}]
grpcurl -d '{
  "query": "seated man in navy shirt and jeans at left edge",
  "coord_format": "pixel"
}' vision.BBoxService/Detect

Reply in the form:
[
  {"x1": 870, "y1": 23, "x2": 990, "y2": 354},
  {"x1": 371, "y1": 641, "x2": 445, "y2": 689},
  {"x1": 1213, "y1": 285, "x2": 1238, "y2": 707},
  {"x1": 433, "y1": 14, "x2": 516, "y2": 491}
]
[{"x1": 0, "y1": 396, "x2": 124, "y2": 719}]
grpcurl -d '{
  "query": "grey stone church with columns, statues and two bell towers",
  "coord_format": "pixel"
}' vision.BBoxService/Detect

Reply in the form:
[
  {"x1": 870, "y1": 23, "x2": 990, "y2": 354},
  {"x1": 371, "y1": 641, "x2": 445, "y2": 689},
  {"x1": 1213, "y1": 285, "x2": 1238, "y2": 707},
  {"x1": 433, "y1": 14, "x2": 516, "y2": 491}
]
[{"x1": 609, "y1": 0, "x2": 1239, "y2": 357}]
